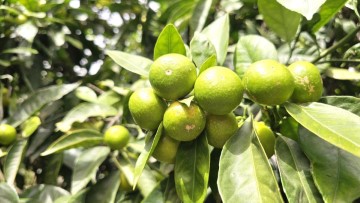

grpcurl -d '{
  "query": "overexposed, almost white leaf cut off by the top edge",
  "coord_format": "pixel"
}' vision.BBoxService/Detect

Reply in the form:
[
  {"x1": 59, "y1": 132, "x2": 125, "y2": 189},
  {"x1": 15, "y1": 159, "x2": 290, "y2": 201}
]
[{"x1": 276, "y1": 0, "x2": 331, "y2": 20}]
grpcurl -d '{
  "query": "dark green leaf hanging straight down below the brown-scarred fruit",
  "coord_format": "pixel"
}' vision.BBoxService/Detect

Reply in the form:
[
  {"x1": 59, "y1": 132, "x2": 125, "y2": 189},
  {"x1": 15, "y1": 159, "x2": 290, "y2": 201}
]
[{"x1": 174, "y1": 133, "x2": 210, "y2": 202}]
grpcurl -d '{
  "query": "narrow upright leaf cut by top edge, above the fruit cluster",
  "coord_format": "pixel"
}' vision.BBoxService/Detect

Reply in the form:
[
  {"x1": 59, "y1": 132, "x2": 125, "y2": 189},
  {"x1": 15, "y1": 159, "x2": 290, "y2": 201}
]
[{"x1": 190, "y1": 0, "x2": 212, "y2": 33}]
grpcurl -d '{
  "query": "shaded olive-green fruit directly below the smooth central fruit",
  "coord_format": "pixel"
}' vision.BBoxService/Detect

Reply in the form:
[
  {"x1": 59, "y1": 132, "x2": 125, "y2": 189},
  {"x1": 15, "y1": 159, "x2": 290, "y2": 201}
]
[{"x1": 205, "y1": 113, "x2": 238, "y2": 148}]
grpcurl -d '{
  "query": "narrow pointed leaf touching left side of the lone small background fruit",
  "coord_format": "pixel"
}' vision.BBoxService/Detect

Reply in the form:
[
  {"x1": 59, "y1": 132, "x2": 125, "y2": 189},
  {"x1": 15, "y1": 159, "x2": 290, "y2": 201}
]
[{"x1": 41, "y1": 129, "x2": 103, "y2": 156}]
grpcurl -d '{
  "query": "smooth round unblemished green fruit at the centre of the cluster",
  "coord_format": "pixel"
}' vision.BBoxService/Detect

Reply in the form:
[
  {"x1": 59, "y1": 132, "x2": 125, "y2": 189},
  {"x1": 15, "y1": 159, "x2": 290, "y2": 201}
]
[{"x1": 194, "y1": 66, "x2": 244, "y2": 115}]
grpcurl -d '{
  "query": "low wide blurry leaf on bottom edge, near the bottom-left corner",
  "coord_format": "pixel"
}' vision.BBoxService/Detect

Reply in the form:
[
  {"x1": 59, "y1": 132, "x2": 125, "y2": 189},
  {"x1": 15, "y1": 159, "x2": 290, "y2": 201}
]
[{"x1": 20, "y1": 184, "x2": 70, "y2": 203}]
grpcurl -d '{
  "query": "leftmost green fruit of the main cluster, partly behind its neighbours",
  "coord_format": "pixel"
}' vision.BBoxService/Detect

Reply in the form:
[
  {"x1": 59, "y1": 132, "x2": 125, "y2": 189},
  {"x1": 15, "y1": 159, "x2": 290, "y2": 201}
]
[{"x1": 129, "y1": 88, "x2": 167, "y2": 130}]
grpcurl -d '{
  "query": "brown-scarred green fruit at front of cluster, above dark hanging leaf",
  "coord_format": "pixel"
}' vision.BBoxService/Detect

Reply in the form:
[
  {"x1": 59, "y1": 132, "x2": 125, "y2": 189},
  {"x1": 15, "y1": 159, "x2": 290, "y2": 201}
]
[{"x1": 163, "y1": 102, "x2": 206, "y2": 141}]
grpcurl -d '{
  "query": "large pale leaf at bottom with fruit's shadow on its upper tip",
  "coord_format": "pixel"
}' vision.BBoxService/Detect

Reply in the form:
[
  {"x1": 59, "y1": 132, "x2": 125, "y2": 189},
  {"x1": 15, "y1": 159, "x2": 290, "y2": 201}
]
[{"x1": 217, "y1": 117, "x2": 283, "y2": 203}]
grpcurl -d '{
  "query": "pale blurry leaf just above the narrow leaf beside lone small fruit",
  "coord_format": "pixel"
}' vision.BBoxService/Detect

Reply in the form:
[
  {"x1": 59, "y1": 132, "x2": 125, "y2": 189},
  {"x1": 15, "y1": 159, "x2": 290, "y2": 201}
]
[{"x1": 56, "y1": 103, "x2": 118, "y2": 132}]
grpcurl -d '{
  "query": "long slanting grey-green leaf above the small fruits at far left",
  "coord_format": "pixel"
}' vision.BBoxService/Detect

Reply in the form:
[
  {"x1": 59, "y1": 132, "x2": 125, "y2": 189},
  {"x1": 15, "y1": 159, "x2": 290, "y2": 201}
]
[{"x1": 8, "y1": 83, "x2": 79, "y2": 127}]
